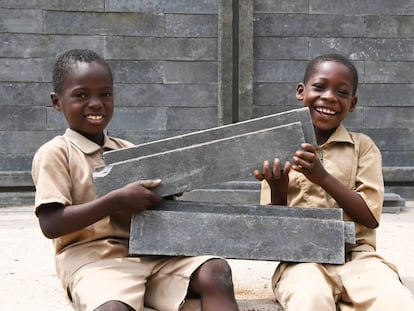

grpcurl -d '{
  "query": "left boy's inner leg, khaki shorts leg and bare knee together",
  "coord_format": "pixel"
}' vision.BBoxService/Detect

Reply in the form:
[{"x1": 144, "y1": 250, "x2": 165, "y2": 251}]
[{"x1": 145, "y1": 256, "x2": 238, "y2": 311}]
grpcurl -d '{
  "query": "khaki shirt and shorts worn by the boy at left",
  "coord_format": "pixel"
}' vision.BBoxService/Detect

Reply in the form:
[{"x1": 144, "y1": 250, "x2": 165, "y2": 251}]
[{"x1": 32, "y1": 129, "x2": 217, "y2": 310}]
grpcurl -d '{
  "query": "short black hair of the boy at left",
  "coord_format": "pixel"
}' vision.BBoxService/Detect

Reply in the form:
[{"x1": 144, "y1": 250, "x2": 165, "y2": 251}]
[{"x1": 53, "y1": 49, "x2": 112, "y2": 94}]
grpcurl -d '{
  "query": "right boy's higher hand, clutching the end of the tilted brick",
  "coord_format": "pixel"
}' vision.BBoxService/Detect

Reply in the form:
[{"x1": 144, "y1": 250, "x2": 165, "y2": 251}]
[{"x1": 292, "y1": 143, "x2": 328, "y2": 185}]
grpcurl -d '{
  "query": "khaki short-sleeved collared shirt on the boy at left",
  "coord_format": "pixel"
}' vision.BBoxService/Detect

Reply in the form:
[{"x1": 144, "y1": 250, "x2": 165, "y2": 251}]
[{"x1": 32, "y1": 129, "x2": 133, "y2": 279}]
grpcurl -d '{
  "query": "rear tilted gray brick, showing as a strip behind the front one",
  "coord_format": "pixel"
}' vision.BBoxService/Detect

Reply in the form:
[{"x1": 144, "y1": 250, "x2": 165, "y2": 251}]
[{"x1": 103, "y1": 108, "x2": 316, "y2": 165}]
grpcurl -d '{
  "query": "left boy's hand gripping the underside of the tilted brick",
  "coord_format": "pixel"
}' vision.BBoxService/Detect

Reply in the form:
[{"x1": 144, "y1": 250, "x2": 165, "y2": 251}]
[{"x1": 115, "y1": 179, "x2": 163, "y2": 213}]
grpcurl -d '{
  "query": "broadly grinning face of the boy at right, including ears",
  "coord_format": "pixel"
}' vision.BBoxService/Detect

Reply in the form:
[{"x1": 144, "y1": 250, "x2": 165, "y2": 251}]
[{"x1": 296, "y1": 61, "x2": 357, "y2": 144}]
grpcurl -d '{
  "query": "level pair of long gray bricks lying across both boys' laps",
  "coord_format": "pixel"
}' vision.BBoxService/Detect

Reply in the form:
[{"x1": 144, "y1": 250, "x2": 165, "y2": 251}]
[{"x1": 129, "y1": 202, "x2": 355, "y2": 264}]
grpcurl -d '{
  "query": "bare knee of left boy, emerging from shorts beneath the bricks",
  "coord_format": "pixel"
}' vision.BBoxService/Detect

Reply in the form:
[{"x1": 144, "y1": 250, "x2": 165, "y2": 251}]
[{"x1": 189, "y1": 259, "x2": 239, "y2": 311}]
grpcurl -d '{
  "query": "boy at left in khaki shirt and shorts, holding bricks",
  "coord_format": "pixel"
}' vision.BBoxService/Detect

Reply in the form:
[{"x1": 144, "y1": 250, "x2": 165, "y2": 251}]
[{"x1": 32, "y1": 50, "x2": 238, "y2": 311}]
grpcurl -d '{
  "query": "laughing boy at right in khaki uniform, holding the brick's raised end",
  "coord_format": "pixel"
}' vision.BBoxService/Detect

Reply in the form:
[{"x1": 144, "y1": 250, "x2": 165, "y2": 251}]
[{"x1": 254, "y1": 54, "x2": 414, "y2": 311}]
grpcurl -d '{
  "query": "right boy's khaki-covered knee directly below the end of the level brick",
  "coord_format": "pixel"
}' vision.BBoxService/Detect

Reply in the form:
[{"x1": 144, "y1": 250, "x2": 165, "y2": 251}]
[{"x1": 273, "y1": 263, "x2": 339, "y2": 311}]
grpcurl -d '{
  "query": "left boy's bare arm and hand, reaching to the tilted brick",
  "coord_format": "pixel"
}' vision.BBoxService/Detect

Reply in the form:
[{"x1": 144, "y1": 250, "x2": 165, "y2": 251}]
[{"x1": 38, "y1": 180, "x2": 163, "y2": 238}]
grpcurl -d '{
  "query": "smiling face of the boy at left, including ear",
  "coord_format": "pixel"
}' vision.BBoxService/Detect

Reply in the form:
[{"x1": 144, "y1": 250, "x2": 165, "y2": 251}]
[{"x1": 51, "y1": 62, "x2": 114, "y2": 144}]
